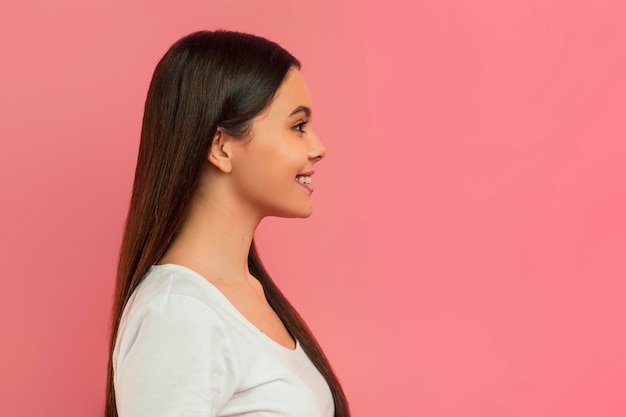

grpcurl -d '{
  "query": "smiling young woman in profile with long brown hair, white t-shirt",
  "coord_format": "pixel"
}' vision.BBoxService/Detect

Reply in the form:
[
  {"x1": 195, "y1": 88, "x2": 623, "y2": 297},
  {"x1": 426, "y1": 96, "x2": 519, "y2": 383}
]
[{"x1": 100, "y1": 31, "x2": 350, "y2": 417}]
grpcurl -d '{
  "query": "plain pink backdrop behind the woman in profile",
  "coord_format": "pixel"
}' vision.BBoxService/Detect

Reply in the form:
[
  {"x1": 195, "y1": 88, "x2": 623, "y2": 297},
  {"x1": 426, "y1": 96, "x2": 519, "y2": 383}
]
[{"x1": 0, "y1": 0, "x2": 626, "y2": 417}]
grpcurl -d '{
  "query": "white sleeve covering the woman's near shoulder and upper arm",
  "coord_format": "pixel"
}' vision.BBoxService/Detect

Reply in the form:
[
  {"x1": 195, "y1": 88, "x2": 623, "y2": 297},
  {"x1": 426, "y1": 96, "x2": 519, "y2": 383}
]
[{"x1": 114, "y1": 294, "x2": 237, "y2": 417}]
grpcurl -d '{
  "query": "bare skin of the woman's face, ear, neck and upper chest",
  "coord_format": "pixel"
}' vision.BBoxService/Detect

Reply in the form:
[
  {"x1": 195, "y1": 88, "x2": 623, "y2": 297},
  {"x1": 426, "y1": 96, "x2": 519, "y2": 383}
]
[{"x1": 159, "y1": 68, "x2": 326, "y2": 349}]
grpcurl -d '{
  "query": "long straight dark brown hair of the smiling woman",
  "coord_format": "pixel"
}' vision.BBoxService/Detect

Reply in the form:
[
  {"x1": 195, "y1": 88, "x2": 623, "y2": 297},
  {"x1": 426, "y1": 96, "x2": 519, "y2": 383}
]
[{"x1": 104, "y1": 31, "x2": 350, "y2": 417}]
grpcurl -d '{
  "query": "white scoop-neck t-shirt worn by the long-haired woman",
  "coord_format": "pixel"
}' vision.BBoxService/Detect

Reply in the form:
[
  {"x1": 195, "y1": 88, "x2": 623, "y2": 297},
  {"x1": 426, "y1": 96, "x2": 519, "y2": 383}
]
[{"x1": 113, "y1": 265, "x2": 334, "y2": 417}]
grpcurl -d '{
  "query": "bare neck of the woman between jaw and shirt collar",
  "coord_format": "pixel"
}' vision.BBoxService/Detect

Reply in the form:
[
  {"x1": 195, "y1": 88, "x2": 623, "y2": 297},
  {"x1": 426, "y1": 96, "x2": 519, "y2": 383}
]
[{"x1": 159, "y1": 187, "x2": 261, "y2": 284}]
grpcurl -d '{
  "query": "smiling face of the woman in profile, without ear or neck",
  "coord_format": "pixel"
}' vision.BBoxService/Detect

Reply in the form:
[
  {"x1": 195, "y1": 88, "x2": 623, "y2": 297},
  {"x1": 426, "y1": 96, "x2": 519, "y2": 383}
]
[{"x1": 232, "y1": 68, "x2": 326, "y2": 217}]
